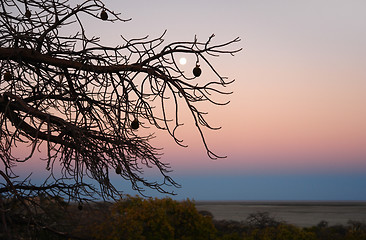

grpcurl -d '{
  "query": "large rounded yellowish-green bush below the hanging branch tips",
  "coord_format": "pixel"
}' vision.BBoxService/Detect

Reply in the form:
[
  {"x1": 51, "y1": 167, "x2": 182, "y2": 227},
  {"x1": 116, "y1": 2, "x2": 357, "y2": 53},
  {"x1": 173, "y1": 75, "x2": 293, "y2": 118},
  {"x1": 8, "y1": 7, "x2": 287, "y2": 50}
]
[{"x1": 93, "y1": 196, "x2": 216, "y2": 240}]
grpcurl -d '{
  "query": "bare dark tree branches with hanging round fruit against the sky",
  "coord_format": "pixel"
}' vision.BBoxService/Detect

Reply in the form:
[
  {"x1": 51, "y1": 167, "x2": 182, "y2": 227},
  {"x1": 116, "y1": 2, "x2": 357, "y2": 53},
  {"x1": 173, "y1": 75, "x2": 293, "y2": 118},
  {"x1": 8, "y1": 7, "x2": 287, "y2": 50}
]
[{"x1": 0, "y1": 0, "x2": 240, "y2": 206}]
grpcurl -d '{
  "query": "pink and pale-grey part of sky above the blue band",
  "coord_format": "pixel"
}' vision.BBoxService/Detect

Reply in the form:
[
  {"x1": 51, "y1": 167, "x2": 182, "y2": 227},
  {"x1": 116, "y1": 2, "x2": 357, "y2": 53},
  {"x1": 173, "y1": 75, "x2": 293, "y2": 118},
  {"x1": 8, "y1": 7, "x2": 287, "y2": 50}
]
[{"x1": 131, "y1": 1, "x2": 366, "y2": 172}]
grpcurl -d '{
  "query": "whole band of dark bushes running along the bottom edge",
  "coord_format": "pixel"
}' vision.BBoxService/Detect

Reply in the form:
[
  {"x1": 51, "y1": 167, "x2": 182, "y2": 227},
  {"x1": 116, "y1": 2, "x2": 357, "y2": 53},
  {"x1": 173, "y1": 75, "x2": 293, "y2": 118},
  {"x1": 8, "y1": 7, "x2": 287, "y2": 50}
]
[{"x1": 0, "y1": 196, "x2": 366, "y2": 240}]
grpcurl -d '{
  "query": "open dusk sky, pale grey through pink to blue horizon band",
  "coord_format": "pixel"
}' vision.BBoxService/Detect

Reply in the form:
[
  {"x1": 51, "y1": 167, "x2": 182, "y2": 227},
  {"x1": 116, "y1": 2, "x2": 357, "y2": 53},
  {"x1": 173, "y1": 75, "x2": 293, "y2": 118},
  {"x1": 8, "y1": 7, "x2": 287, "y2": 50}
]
[{"x1": 10, "y1": 0, "x2": 366, "y2": 201}]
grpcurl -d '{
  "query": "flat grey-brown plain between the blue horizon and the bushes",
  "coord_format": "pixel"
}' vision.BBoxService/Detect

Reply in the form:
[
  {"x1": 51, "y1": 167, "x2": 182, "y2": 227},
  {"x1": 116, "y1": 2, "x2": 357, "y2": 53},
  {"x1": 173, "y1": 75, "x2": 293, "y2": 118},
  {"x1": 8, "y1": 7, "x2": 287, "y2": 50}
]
[{"x1": 195, "y1": 201, "x2": 366, "y2": 227}]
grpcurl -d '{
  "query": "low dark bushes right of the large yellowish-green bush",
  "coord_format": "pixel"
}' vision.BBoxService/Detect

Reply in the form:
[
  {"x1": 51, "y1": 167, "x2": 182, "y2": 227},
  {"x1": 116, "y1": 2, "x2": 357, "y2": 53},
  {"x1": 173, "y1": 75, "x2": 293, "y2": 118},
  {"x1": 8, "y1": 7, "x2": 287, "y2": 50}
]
[{"x1": 213, "y1": 215, "x2": 366, "y2": 240}]
